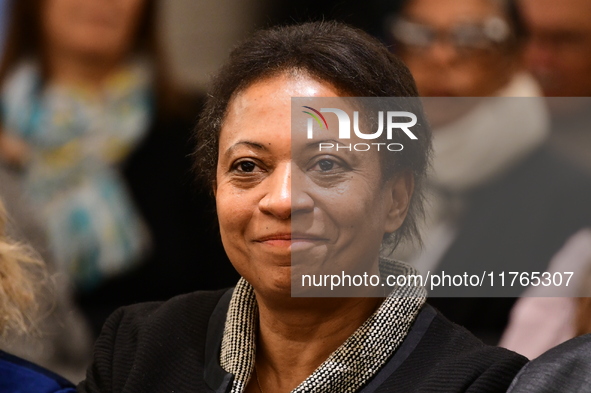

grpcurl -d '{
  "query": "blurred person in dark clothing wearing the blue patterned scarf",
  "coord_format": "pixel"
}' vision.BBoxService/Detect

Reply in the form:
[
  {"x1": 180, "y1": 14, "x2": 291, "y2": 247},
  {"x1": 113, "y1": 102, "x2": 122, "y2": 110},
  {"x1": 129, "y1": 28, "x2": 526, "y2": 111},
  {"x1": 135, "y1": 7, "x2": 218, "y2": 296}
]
[{"x1": 0, "y1": 0, "x2": 236, "y2": 332}]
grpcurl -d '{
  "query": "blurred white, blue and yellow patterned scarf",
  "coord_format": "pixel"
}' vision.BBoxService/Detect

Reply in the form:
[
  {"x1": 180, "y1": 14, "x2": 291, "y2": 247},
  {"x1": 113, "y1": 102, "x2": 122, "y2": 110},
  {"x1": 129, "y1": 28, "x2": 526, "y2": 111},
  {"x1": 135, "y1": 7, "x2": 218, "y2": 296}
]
[{"x1": 0, "y1": 63, "x2": 151, "y2": 289}]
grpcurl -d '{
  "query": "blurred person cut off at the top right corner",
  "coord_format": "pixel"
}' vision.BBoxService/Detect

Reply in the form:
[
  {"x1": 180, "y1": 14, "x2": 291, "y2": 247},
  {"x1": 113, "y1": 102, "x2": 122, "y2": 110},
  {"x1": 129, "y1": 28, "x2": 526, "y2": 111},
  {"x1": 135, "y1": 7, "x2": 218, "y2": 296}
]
[{"x1": 518, "y1": 0, "x2": 591, "y2": 173}]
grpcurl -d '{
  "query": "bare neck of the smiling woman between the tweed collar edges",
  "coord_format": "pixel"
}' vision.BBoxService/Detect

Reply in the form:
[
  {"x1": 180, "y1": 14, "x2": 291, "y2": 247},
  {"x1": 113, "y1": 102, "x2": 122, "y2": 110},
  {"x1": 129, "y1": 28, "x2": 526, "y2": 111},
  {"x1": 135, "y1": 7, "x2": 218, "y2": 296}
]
[{"x1": 256, "y1": 297, "x2": 383, "y2": 392}]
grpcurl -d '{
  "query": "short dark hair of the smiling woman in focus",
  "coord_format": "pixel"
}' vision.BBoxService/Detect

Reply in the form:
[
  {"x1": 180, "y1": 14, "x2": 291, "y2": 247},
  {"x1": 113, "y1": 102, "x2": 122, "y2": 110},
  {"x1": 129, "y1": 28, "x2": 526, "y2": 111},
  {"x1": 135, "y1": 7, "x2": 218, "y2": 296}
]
[{"x1": 194, "y1": 22, "x2": 431, "y2": 248}]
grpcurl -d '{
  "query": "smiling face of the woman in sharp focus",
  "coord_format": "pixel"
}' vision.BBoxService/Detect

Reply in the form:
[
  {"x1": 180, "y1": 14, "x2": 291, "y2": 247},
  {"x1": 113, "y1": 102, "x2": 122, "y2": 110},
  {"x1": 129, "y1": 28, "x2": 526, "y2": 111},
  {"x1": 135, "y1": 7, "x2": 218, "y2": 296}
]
[{"x1": 214, "y1": 75, "x2": 412, "y2": 296}]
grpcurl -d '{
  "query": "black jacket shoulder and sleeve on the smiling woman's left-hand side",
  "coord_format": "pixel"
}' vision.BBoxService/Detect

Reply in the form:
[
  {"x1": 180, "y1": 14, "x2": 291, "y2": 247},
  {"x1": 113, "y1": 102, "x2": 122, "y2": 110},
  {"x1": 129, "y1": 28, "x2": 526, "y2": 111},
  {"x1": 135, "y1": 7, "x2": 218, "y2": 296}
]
[{"x1": 78, "y1": 290, "x2": 226, "y2": 393}]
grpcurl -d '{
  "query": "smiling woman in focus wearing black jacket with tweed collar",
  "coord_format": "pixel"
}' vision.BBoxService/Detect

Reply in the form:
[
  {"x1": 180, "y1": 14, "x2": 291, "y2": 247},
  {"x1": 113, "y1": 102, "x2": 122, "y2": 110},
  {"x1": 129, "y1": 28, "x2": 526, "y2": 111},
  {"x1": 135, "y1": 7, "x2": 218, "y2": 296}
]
[{"x1": 79, "y1": 23, "x2": 525, "y2": 393}]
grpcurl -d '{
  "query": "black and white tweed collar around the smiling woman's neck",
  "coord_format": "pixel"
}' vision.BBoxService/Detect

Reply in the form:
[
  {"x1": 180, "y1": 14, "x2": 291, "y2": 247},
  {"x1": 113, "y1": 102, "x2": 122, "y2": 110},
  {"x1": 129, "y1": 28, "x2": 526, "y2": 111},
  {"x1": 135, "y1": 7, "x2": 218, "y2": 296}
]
[{"x1": 220, "y1": 260, "x2": 426, "y2": 393}]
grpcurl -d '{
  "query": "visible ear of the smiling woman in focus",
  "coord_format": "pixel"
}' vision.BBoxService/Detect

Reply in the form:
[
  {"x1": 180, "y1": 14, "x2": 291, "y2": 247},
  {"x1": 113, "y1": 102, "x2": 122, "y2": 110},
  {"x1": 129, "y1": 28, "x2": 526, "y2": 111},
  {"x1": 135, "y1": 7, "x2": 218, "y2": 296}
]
[{"x1": 384, "y1": 171, "x2": 415, "y2": 233}]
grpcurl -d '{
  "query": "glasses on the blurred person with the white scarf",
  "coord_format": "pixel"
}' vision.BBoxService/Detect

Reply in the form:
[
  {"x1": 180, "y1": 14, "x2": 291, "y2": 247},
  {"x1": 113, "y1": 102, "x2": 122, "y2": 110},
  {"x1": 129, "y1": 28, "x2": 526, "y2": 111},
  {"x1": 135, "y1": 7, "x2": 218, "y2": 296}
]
[{"x1": 390, "y1": 16, "x2": 511, "y2": 53}]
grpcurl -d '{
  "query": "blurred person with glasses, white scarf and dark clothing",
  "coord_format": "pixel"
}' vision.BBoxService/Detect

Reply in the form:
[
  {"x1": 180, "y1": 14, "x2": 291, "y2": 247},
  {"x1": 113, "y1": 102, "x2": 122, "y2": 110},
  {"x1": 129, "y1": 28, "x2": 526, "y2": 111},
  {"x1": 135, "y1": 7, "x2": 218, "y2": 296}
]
[{"x1": 387, "y1": 0, "x2": 591, "y2": 343}]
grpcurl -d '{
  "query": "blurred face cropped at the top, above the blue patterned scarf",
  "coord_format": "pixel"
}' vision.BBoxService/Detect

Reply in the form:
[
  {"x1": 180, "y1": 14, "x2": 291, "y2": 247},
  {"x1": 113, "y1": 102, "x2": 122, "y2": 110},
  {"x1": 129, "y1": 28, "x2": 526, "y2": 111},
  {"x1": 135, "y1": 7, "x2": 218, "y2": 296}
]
[{"x1": 42, "y1": 0, "x2": 145, "y2": 61}]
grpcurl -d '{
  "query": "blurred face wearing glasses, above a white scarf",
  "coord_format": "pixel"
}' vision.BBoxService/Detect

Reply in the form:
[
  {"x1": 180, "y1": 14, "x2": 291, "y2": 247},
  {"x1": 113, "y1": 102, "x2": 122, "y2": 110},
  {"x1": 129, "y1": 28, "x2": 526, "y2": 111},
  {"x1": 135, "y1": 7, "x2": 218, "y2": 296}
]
[{"x1": 390, "y1": 0, "x2": 519, "y2": 97}]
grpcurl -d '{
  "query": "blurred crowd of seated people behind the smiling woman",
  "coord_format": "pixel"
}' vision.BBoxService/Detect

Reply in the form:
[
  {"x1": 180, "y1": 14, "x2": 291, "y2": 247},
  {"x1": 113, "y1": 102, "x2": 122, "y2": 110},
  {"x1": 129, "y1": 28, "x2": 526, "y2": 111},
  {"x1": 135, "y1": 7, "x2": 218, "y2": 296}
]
[{"x1": 0, "y1": 0, "x2": 591, "y2": 382}]
